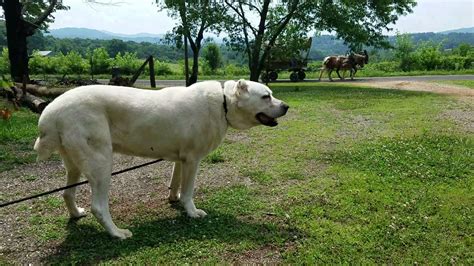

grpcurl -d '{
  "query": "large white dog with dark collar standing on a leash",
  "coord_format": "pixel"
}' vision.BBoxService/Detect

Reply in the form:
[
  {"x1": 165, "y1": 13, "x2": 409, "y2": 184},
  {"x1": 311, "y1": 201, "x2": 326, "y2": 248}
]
[{"x1": 34, "y1": 80, "x2": 288, "y2": 239}]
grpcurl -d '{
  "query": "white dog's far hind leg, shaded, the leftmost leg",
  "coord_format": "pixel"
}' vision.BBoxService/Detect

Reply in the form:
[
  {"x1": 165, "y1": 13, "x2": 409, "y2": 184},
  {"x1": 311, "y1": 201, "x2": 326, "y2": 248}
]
[{"x1": 59, "y1": 148, "x2": 86, "y2": 218}]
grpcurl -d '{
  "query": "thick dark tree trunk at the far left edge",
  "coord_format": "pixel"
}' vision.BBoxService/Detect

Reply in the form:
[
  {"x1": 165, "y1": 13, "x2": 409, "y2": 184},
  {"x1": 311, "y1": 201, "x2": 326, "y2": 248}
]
[{"x1": 3, "y1": 0, "x2": 30, "y2": 82}]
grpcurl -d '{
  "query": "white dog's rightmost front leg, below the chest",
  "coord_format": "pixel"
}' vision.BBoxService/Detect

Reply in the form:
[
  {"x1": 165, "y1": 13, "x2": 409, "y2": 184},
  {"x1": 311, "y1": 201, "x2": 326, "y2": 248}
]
[{"x1": 180, "y1": 160, "x2": 207, "y2": 218}]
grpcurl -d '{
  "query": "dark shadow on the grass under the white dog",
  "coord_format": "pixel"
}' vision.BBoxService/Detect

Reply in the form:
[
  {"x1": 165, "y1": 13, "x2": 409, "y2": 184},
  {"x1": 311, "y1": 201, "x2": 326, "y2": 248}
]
[{"x1": 41, "y1": 211, "x2": 302, "y2": 264}]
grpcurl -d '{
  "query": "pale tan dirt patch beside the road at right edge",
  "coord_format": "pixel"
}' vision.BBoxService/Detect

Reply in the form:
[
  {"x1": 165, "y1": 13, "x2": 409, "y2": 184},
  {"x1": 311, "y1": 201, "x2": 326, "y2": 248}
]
[{"x1": 351, "y1": 81, "x2": 474, "y2": 97}]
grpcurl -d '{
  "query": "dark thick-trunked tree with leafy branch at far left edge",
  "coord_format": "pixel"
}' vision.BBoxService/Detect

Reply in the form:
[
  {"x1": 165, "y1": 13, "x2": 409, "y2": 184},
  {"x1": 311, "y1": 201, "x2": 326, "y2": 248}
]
[{"x1": 0, "y1": 0, "x2": 67, "y2": 82}]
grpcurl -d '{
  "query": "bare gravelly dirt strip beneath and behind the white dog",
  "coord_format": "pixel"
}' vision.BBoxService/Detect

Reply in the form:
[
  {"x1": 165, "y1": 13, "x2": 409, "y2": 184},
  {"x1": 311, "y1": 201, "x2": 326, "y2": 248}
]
[{"x1": 0, "y1": 139, "x2": 252, "y2": 264}]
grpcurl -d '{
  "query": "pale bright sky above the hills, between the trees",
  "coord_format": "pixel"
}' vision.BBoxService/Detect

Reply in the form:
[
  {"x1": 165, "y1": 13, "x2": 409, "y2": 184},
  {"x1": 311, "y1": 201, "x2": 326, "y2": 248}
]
[{"x1": 42, "y1": 0, "x2": 474, "y2": 34}]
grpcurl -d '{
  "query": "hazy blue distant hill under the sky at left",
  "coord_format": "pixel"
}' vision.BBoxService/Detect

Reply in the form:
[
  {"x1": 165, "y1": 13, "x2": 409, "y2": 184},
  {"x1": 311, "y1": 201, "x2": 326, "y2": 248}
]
[{"x1": 44, "y1": 28, "x2": 164, "y2": 43}]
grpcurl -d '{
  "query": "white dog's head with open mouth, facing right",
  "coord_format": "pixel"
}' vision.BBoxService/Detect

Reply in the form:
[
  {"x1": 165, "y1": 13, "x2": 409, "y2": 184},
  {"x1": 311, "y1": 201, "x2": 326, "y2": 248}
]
[{"x1": 224, "y1": 79, "x2": 289, "y2": 129}]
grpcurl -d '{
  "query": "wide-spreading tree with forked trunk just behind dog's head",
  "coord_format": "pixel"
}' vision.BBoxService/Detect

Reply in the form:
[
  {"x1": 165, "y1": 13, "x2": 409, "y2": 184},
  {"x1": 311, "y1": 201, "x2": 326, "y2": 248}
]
[{"x1": 225, "y1": 0, "x2": 416, "y2": 81}]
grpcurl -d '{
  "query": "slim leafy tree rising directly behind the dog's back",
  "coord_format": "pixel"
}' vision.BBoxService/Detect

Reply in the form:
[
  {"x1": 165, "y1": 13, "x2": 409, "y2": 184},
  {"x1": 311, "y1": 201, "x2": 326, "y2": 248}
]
[{"x1": 156, "y1": 0, "x2": 226, "y2": 85}]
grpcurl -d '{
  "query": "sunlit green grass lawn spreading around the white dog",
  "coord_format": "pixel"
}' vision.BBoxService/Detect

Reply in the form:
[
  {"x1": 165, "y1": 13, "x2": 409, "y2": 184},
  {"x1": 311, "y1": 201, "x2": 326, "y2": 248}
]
[{"x1": 0, "y1": 83, "x2": 474, "y2": 264}]
